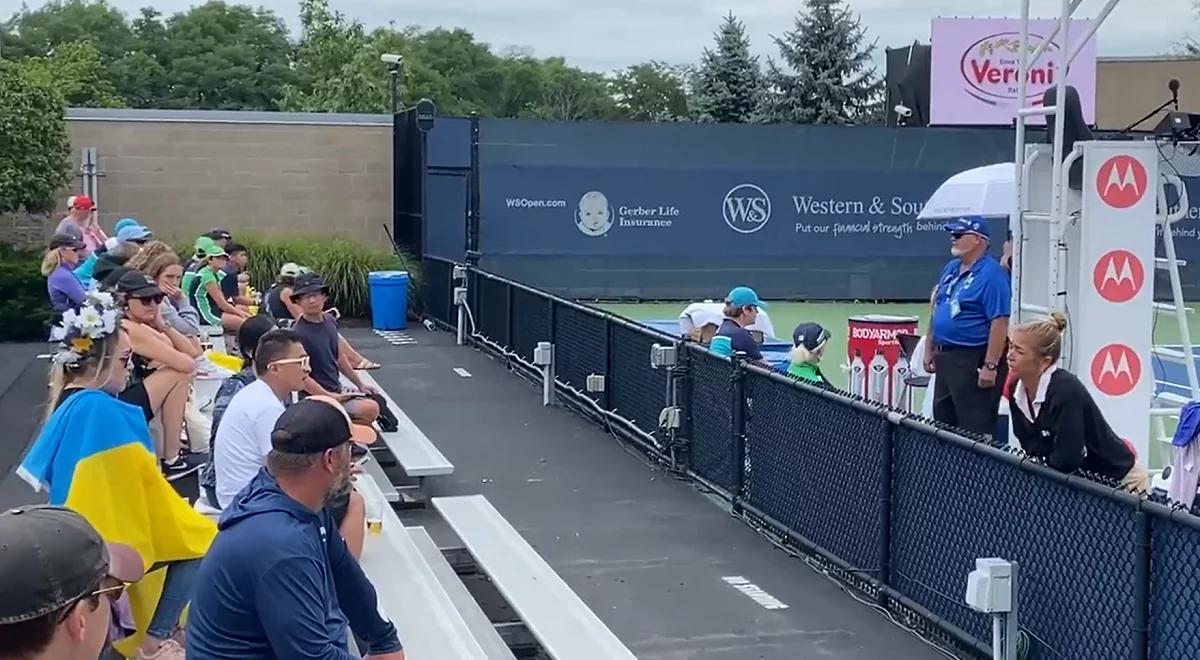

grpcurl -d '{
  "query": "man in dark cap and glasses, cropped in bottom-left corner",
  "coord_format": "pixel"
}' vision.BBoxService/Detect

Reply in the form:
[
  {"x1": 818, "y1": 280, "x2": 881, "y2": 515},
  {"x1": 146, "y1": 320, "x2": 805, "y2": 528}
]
[{"x1": 0, "y1": 506, "x2": 143, "y2": 660}]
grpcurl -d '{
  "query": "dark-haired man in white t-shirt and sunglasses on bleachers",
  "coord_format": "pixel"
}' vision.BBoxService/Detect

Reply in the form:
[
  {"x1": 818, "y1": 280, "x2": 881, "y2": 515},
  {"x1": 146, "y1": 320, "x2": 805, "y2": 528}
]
[{"x1": 212, "y1": 330, "x2": 308, "y2": 509}]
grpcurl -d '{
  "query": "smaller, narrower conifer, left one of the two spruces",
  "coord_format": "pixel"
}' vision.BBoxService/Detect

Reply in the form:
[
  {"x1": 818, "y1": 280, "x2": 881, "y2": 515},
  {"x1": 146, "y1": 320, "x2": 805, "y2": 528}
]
[{"x1": 692, "y1": 13, "x2": 762, "y2": 122}]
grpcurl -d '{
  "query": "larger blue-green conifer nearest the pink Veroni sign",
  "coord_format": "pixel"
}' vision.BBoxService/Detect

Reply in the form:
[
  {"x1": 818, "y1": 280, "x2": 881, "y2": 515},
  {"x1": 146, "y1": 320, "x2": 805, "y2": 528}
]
[{"x1": 764, "y1": 0, "x2": 883, "y2": 124}]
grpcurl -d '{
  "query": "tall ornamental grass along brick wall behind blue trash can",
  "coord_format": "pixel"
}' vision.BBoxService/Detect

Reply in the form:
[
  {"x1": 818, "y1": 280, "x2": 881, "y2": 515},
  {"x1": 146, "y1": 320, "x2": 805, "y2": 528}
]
[{"x1": 176, "y1": 232, "x2": 421, "y2": 318}]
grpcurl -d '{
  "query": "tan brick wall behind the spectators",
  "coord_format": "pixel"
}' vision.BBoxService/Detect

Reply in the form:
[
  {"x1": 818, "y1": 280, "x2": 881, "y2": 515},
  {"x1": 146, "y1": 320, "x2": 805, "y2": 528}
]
[{"x1": 64, "y1": 109, "x2": 391, "y2": 245}]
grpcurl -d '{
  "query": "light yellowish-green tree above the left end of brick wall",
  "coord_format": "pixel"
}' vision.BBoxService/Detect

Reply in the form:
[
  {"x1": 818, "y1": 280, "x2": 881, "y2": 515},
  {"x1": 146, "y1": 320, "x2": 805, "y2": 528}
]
[{"x1": 22, "y1": 41, "x2": 125, "y2": 108}]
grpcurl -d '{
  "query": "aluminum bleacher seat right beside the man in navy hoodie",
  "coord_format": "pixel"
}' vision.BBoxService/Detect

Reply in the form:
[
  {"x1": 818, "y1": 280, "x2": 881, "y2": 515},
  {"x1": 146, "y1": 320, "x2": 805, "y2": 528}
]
[{"x1": 354, "y1": 470, "x2": 492, "y2": 660}]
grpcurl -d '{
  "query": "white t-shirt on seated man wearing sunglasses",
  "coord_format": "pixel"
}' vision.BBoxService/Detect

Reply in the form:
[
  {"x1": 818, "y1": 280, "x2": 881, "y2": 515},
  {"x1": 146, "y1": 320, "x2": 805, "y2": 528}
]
[{"x1": 212, "y1": 379, "x2": 283, "y2": 509}]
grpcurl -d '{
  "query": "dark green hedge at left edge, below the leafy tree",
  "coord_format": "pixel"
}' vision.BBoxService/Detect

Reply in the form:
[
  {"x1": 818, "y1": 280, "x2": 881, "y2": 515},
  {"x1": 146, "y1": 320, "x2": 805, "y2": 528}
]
[{"x1": 0, "y1": 244, "x2": 54, "y2": 342}]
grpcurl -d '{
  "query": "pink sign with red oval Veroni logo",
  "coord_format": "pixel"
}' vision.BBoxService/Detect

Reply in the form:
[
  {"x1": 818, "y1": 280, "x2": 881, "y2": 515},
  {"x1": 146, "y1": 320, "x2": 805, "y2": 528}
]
[{"x1": 929, "y1": 18, "x2": 1096, "y2": 125}]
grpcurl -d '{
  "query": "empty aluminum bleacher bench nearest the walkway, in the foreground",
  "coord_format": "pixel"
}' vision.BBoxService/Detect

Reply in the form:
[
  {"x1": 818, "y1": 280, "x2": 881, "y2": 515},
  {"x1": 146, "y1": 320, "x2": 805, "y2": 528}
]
[{"x1": 433, "y1": 496, "x2": 635, "y2": 660}]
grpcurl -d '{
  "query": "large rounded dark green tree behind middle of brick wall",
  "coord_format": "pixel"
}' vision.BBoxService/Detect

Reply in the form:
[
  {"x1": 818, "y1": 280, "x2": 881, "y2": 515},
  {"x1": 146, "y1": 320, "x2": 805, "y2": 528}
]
[{"x1": 160, "y1": 0, "x2": 294, "y2": 110}]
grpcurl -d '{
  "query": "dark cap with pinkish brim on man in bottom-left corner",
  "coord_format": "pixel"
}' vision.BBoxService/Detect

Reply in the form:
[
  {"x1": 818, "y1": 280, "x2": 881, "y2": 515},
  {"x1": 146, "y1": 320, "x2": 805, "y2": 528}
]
[{"x1": 0, "y1": 505, "x2": 144, "y2": 625}]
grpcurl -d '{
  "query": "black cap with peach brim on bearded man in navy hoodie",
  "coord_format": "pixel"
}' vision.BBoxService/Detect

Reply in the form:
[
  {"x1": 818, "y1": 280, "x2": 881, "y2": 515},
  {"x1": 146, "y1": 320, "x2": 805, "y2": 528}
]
[{"x1": 271, "y1": 395, "x2": 378, "y2": 454}]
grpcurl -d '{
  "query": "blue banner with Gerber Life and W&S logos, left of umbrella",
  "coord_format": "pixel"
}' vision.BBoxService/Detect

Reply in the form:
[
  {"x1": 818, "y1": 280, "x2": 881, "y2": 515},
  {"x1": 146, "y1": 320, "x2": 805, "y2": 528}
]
[{"x1": 480, "y1": 167, "x2": 979, "y2": 257}]
